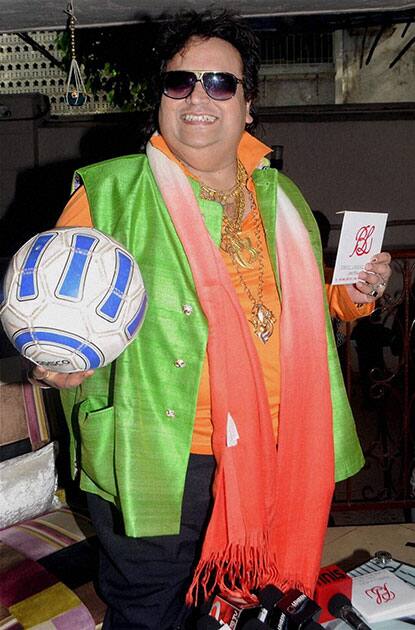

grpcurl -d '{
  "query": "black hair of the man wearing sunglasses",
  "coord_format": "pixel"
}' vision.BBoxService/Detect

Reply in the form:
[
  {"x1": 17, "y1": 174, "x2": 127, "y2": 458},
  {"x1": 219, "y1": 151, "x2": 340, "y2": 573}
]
[{"x1": 146, "y1": 10, "x2": 260, "y2": 143}]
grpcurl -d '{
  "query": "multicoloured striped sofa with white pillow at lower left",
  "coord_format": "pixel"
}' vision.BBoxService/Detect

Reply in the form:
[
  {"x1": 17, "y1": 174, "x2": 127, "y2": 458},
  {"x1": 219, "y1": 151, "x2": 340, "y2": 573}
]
[{"x1": 0, "y1": 356, "x2": 105, "y2": 630}]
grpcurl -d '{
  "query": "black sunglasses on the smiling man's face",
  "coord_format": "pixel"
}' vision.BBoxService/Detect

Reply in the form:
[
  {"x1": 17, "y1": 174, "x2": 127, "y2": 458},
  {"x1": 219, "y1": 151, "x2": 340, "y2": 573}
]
[{"x1": 162, "y1": 70, "x2": 243, "y2": 101}]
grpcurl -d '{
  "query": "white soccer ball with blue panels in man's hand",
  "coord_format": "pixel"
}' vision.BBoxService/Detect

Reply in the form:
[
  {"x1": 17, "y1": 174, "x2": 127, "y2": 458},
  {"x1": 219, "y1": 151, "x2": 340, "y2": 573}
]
[{"x1": 0, "y1": 228, "x2": 147, "y2": 372}]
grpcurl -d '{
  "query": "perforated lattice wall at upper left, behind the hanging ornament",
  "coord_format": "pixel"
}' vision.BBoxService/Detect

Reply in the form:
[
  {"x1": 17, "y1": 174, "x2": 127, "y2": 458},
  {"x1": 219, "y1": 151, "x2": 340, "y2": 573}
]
[{"x1": 0, "y1": 31, "x2": 117, "y2": 115}]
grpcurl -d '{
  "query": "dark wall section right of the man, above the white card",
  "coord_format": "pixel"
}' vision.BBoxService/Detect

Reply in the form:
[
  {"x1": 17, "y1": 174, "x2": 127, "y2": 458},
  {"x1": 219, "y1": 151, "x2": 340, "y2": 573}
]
[{"x1": 261, "y1": 112, "x2": 415, "y2": 247}]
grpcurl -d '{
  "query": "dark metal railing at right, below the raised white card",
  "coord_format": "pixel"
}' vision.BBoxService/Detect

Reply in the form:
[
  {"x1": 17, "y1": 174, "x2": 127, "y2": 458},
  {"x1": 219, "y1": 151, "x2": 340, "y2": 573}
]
[{"x1": 333, "y1": 249, "x2": 415, "y2": 519}]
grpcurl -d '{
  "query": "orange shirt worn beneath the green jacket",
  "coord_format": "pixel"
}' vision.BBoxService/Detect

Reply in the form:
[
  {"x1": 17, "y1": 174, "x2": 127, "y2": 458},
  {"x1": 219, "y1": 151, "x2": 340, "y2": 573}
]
[{"x1": 57, "y1": 134, "x2": 370, "y2": 454}]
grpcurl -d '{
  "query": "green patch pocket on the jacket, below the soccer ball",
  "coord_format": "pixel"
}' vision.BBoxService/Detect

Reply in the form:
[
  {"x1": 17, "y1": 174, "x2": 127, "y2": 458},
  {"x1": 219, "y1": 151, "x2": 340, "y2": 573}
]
[{"x1": 78, "y1": 400, "x2": 117, "y2": 496}]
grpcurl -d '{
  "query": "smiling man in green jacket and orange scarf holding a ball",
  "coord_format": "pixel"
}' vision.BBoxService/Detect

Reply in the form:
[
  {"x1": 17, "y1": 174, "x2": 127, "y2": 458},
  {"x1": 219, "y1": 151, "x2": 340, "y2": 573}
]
[{"x1": 32, "y1": 13, "x2": 390, "y2": 630}]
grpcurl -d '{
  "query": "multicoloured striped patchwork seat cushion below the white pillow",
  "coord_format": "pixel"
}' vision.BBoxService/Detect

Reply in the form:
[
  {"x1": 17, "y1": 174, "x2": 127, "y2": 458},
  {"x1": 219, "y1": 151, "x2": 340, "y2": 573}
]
[{"x1": 0, "y1": 507, "x2": 105, "y2": 630}]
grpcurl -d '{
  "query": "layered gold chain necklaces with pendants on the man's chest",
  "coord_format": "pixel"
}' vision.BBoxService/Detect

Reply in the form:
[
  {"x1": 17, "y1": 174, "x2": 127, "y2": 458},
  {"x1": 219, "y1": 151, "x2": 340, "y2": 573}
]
[{"x1": 200, "y1": 160, "x2": 276, "y2": 343}]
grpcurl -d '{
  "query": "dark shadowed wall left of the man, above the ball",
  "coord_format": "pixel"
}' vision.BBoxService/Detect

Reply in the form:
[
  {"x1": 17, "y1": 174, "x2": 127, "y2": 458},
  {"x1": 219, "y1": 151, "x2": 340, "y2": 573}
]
[{"x1": 0, "y1": 100, "x2": 144, "y2": 258}]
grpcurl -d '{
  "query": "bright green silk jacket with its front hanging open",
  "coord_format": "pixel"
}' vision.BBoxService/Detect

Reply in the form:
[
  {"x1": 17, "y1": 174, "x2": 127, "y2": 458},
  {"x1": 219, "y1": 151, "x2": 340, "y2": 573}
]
[{"x1": 61, "y1": 155, "x2": 363, "y2": 537}]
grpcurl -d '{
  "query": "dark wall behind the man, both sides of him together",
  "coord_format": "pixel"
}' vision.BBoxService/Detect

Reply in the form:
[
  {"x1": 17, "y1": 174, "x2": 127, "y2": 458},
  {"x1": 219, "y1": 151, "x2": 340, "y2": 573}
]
[{"x1": 0, "y1": 94, "x2": 415, "y2": 256}]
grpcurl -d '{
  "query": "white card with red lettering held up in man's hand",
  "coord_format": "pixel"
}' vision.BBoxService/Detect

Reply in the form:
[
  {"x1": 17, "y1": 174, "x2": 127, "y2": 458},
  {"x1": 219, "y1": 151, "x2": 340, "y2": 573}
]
[{"x1": 331, "y1": 212, "x2": 388, "y2": 284}]
